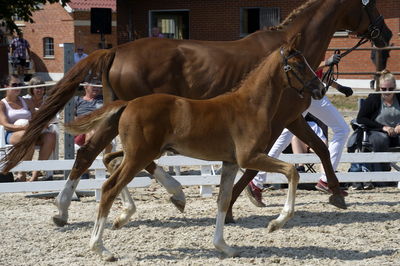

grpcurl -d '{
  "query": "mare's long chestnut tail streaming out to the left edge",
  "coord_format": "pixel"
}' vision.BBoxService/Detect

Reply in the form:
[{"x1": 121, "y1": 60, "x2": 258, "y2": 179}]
[{"x1": 1, "y1": 49, "x2": 115, "y2": 172}]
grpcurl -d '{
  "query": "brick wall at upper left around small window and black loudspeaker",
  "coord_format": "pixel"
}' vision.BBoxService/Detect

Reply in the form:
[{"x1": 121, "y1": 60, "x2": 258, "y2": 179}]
[{"x1": 22, "y1": 3, "x2": 117, "y2": 79}]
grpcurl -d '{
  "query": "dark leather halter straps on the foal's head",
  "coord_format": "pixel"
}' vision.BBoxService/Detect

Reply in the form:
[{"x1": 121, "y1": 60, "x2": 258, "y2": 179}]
[{"x1": 280, "y1": 47, "x2": 326, "y2": 98}]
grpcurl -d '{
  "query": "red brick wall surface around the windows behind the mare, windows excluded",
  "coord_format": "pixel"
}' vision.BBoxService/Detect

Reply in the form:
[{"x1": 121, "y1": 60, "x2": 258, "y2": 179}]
[{"x1": 117, "y1": 0, "x2": 400, "y2": 78}]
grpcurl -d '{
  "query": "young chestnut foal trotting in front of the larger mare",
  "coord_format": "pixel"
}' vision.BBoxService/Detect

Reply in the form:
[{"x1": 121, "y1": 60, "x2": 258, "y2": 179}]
[{"x1": 66, "y1": 38, "x2": 325, "y2": 261}]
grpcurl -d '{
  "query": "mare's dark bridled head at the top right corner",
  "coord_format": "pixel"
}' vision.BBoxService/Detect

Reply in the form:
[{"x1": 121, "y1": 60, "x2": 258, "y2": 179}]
[{"x1": 341, "y1": 0, "x2": 395, "y2": 47}]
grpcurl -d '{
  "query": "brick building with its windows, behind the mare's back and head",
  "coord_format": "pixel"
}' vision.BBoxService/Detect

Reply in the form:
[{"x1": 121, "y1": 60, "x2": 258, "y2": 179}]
[{"x1": 117, "y1": 0, "x2": 400, "y2": 82}]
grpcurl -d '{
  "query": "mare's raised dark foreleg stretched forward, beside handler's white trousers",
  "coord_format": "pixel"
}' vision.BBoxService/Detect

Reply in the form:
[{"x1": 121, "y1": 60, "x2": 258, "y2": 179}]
[{"x1": 287, "y1": 116, "x2": 347, "y2": 209}]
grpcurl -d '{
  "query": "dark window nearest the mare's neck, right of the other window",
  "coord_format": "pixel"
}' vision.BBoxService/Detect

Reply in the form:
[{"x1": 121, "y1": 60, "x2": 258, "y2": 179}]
[{"x1": 240, "y1": 7, "x2": 281, "y2": 37}]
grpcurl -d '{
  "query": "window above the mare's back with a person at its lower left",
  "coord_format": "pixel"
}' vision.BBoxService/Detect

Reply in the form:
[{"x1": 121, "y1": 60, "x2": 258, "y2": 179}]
[{"x1": 149, "y1": 10, "x2": 189, "y2": 39}]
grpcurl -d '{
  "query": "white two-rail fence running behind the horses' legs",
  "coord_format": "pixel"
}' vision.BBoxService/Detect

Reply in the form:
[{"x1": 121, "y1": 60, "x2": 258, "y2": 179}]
[{"x1": 0, "y1": 152, "x2": 400, "y2": 197}]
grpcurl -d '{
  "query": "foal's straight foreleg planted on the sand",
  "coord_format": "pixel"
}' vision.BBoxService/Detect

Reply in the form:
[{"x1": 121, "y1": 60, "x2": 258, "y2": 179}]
[{"x1": 213, "y1": 162, "x2": 239, "y2": 257}]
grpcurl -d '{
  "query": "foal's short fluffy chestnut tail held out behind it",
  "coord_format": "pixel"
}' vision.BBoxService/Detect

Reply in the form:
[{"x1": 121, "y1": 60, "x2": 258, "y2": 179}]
[{"x1": 65, "y1": 100, "x2": 129, "y2": 135}]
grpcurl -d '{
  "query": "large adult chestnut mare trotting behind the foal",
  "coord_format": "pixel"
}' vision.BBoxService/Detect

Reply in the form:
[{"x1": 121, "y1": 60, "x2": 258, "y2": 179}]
[{"x1": 3, "y1": 0, "x2": 391, "y2": 226}]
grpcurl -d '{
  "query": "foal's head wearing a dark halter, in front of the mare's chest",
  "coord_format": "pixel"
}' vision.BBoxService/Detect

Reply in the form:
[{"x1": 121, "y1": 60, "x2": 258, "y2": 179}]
[{"x1": 279, "y1": 34, "x2": 326, "y2": 100}]
